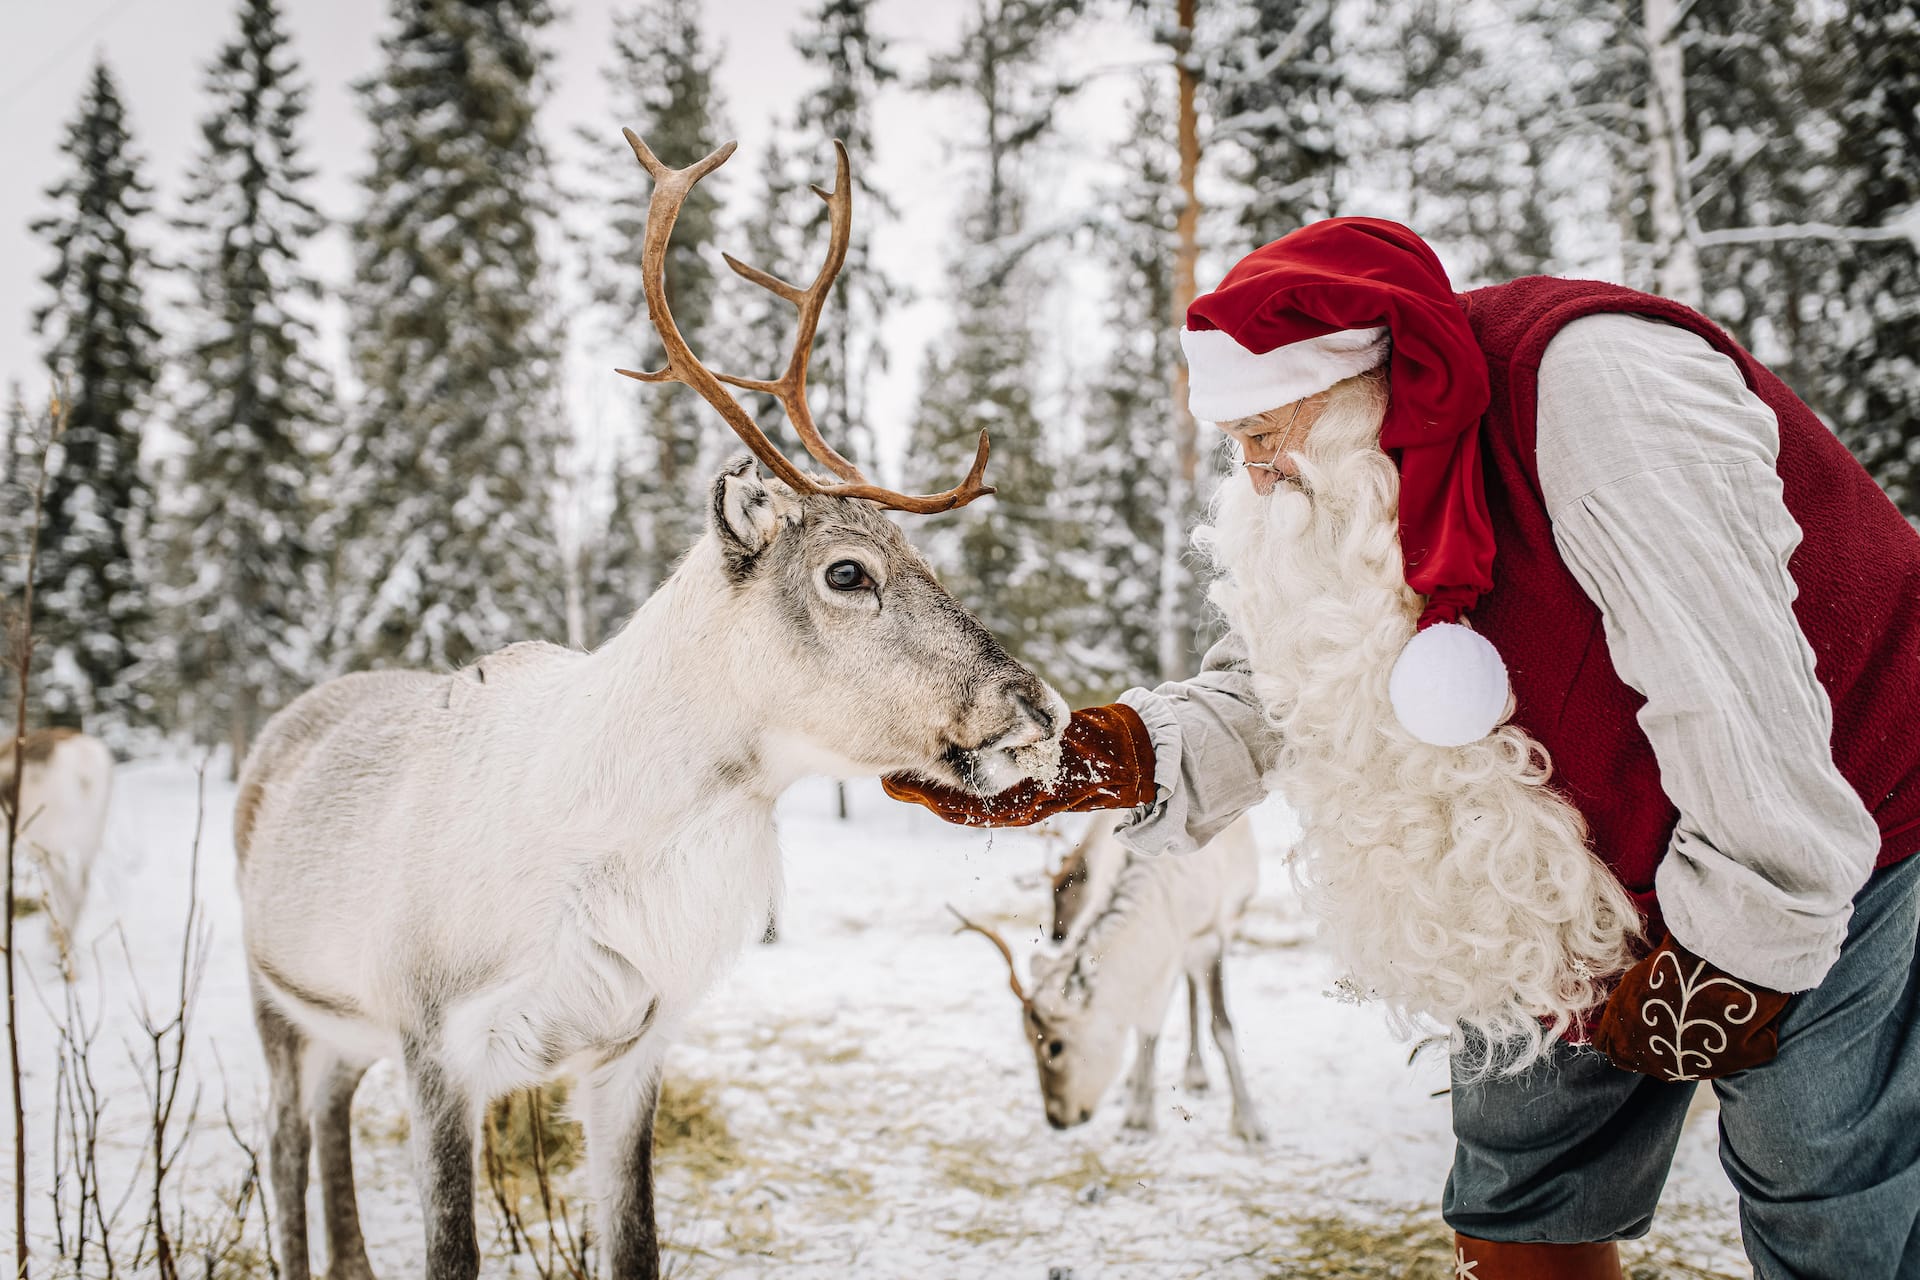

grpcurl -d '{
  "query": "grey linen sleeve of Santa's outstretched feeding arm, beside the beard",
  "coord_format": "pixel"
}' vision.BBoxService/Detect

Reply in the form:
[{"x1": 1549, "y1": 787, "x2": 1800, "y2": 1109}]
[{"x1": 1117, "y1": 631, "x2": 1267, "y2": 854}]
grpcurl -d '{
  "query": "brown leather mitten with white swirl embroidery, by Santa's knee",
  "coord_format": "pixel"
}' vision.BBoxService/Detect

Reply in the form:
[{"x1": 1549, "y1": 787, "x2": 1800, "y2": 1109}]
[{"x1": 1594, "y1": 935, "x2": 1788, "y2": 1080}]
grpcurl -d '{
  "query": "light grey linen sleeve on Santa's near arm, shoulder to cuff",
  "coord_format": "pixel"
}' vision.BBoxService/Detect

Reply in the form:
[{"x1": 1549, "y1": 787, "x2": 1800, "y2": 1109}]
[{"x1": 1536, "y1": 315, "x2": 1880, "y2": 992}]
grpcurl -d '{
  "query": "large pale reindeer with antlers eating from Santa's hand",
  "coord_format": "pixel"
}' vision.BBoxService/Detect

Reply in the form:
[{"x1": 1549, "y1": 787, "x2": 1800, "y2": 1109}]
[{"x1": 234, "y1": 132, "x2": 1066, "y2": 1280}]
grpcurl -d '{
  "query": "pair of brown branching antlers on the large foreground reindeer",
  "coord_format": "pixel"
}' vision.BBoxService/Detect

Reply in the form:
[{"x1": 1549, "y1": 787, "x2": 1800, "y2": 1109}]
[{"x1": 618, "y1": 129, "x2": 993, "y2": 514}]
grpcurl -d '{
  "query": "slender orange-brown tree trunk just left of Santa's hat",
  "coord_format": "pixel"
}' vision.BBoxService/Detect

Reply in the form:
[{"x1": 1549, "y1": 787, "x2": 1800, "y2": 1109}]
[{"x1": 1160, "y1": 0, "x2": 1200, "y2": 679}]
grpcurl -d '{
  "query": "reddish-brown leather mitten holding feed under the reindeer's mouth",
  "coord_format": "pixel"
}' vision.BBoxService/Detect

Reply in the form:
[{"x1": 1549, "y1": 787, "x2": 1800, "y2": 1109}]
[{"x1": 881, "y1": 702, "x2": 1154, "y2": 827}]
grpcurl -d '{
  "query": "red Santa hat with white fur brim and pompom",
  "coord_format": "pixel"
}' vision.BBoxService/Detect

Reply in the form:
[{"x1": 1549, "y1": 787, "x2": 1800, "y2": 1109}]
[{"x1": 1181, "y1": 217, "x2": 1507, "y2": 745}]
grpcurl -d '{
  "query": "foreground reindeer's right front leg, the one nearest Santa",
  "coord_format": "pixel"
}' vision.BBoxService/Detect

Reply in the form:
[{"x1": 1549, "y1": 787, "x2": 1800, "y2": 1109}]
[{"x1": 582, "y1": 1050, "x2": 660, "y2": 1280}]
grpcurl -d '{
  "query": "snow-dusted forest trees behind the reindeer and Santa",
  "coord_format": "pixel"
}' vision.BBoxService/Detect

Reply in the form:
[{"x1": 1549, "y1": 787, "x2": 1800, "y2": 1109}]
[{"x1": 4, "y1": 0, "x2": 1920, "y2": 752}]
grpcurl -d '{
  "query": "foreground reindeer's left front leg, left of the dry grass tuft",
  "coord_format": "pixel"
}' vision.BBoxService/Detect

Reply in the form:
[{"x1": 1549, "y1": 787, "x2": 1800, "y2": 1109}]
[{"x1": 401, "y1": 1036, "x2": 480, "y2": 1280}]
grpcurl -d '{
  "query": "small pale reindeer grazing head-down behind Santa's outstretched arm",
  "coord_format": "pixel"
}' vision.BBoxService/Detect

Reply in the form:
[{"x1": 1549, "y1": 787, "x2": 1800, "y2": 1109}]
[{"x1": 960, "y1": 818, "x2": 1267, "y2": 1144}]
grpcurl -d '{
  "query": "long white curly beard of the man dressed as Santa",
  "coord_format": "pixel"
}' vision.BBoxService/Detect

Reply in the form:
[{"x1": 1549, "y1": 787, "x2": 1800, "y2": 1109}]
[{"x1": 1198, "y1": 376, "x2": 1638, "y2": 1071}]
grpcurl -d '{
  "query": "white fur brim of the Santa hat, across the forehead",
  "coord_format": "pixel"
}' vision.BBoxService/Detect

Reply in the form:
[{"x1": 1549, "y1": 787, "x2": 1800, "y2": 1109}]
[{"x1": 1181, "y1": 326, "x2": 1386, "y2": 422}]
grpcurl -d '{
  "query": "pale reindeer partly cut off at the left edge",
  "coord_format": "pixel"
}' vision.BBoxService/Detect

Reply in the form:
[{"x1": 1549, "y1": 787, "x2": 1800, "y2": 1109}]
[{"x1": 0, "y1": 729, "x2": 113, "y2": 969}]
